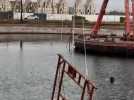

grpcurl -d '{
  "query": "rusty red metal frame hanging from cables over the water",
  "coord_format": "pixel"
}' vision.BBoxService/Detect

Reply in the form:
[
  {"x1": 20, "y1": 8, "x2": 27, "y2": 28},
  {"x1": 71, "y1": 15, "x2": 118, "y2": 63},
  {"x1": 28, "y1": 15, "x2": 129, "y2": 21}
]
[{"x1": 51, "y1": 55, "x2": 96, "y2": 100}]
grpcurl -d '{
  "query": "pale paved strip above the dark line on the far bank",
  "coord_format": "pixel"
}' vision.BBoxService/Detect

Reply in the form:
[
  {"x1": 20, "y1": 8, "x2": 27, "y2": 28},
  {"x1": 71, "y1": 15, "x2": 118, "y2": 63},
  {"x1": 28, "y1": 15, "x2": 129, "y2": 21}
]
[{"x1": 0, "y1": 26, "x2": 89, "y2": 34}]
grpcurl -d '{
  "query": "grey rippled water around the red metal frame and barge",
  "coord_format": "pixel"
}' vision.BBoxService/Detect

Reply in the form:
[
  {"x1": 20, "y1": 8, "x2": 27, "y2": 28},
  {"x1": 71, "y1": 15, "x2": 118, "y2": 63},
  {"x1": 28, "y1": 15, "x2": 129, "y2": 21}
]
[{"x1": 0, "y1": 41, "x2": 134, "y2": 100}]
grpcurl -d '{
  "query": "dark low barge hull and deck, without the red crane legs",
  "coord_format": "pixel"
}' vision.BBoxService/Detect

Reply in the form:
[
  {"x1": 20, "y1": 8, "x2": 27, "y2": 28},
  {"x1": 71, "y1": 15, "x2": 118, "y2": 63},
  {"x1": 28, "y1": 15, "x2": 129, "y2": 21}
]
[{"x1": 75, "y1": 34, "x2": 134, "y2": 57}]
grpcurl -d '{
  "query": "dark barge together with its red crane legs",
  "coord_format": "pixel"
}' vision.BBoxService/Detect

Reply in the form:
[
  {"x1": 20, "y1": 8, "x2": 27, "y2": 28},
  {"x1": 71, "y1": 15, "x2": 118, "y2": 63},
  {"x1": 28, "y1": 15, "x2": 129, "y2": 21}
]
[{"x1": 74, "y1": 0, "x2": 134, "y2": 57}]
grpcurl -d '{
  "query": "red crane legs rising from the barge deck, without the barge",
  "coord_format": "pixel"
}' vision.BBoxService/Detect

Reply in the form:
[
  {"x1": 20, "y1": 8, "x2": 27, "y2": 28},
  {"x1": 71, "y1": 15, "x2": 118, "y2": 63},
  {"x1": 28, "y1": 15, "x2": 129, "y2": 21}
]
[{"x1": 91, "y1": 0, "x2": 134, "y2": 38}]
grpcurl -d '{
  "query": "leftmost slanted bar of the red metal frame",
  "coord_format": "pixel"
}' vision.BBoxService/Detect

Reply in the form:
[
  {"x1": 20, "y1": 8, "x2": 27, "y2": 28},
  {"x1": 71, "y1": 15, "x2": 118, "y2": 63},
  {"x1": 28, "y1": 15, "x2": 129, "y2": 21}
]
[{"x1": 51, "y1": 56, "x2": 61, "y2": 100}]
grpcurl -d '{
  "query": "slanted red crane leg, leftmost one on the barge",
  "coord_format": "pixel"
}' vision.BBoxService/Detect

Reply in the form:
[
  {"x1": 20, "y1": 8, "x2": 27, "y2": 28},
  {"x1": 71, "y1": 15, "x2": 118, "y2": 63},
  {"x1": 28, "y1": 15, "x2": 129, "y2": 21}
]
[{"x1": 92, "y1": 0, "x2": 109, "y2": 35}]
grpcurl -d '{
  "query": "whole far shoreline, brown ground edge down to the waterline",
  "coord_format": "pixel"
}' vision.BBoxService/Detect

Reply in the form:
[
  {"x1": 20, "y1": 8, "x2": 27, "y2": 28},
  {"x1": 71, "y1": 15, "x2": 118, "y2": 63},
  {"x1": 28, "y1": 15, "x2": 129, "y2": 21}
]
[{"x1": 0, "y1": 23, "x2": 124, "y2": 42}]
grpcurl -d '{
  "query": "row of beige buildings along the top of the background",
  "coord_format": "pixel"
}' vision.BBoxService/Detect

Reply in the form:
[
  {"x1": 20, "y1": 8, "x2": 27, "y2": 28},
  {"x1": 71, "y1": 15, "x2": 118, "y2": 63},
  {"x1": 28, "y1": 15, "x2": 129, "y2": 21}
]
[{"x1": 0, "y1": 0, "x2": 95, "y2": 15}]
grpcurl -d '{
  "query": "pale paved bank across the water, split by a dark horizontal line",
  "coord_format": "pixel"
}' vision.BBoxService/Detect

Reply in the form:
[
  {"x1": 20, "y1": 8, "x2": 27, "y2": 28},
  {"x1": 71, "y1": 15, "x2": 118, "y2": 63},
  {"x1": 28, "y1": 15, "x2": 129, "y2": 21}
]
[{"x1": 0, "y1": 25, "x2": 123, "y2": 41}]
